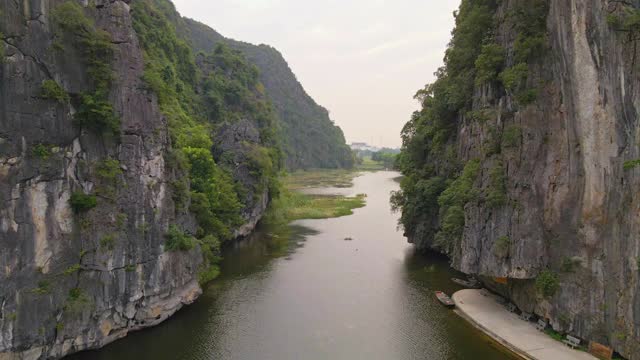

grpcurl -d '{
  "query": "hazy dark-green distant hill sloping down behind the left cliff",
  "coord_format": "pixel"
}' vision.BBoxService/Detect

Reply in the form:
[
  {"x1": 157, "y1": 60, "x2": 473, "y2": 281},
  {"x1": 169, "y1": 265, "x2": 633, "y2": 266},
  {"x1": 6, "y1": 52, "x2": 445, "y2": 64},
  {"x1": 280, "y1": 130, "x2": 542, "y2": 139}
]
[{"x1": 176, "y1": 18, "x2": 354, "y2": 170}]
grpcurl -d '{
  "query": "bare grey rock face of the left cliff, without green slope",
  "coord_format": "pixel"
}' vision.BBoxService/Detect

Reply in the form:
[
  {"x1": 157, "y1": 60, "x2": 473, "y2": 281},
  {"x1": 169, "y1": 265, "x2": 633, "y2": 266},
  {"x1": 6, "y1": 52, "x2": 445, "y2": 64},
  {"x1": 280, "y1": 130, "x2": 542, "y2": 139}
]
[{"x1": 0, "y1": 0, "x2": 269, "y2": 359}]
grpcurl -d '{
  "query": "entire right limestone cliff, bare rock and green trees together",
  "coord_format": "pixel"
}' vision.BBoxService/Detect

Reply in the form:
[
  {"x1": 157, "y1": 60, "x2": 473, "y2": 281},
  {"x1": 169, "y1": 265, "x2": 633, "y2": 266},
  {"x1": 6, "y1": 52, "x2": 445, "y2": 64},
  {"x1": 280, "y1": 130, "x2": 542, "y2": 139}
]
[{"x1": 393, "y1": 0, "x2": 640, "y2": 359}]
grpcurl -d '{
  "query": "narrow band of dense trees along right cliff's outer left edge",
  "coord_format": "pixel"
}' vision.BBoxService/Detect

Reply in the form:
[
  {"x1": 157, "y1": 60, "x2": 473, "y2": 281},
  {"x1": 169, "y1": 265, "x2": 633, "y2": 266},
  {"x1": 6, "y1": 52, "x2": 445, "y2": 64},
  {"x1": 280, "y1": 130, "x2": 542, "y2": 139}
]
[{"x1": 392, "y1": 0, "x2": 503, "y2": 250}]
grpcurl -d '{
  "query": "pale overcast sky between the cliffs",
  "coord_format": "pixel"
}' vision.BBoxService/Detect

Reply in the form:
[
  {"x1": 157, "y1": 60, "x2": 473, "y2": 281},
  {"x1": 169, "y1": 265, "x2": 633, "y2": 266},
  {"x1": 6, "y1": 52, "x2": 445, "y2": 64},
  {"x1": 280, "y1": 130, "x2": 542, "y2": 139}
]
[{"x1": 174, "y1": 0, "x2": 460, "y2": 147}]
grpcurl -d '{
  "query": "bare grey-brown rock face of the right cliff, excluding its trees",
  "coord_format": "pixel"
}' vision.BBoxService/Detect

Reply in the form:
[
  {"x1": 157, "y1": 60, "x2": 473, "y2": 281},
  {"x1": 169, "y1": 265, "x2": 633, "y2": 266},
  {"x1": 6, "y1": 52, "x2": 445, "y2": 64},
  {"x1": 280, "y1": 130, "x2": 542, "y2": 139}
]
[{"x1": 400, "y1": 0, "x2": 640, "y2": 359}]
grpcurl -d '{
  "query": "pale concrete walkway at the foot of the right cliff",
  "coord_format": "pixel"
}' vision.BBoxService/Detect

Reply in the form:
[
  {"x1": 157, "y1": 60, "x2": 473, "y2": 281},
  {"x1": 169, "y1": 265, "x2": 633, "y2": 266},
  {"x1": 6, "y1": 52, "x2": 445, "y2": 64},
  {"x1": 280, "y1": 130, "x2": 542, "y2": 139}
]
[{"x1": 453, "y1": 289, "x2": 596, "y2": 360}]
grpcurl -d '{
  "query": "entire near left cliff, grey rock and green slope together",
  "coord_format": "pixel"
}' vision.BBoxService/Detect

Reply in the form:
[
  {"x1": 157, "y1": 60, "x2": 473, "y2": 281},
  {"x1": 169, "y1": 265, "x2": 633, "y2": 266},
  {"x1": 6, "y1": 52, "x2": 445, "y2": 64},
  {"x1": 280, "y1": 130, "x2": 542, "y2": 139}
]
[{"x1": 0, "y1": 0, "x2": 284, "y2": 359}]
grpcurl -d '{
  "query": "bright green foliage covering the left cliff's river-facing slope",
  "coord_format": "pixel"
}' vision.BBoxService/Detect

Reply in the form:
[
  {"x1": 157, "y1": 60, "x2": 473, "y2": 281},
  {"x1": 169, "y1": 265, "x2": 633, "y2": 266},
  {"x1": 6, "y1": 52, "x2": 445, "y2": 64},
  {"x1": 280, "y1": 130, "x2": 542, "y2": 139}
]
[{"x1": 132, "y1": 0, "x2": 281, "y2": 282}]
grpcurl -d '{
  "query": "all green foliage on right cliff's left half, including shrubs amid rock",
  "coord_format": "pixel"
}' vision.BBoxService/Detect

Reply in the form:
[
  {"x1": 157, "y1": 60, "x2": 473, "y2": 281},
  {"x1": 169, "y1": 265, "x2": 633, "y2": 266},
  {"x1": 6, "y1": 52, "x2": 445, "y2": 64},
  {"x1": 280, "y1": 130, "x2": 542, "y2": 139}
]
[{"x1": 392, "y1": 0, "x2": 549, "y2": 254}]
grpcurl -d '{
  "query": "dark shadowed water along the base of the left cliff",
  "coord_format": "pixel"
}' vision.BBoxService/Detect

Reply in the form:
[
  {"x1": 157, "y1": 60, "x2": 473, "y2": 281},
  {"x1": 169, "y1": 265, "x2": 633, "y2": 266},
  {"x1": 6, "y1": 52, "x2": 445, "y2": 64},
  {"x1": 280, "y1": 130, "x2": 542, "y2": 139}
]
[{"x1": 67, "y1": 225, "x2": 318, "y2": 360}]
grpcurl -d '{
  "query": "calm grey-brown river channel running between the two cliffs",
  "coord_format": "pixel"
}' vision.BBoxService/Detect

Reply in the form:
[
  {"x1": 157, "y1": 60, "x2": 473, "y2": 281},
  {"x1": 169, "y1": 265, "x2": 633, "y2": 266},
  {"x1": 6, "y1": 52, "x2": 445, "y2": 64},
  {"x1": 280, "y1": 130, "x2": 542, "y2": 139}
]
[{"x1": 72, "y1": 172, "x2": 510, "y2": 360}]
